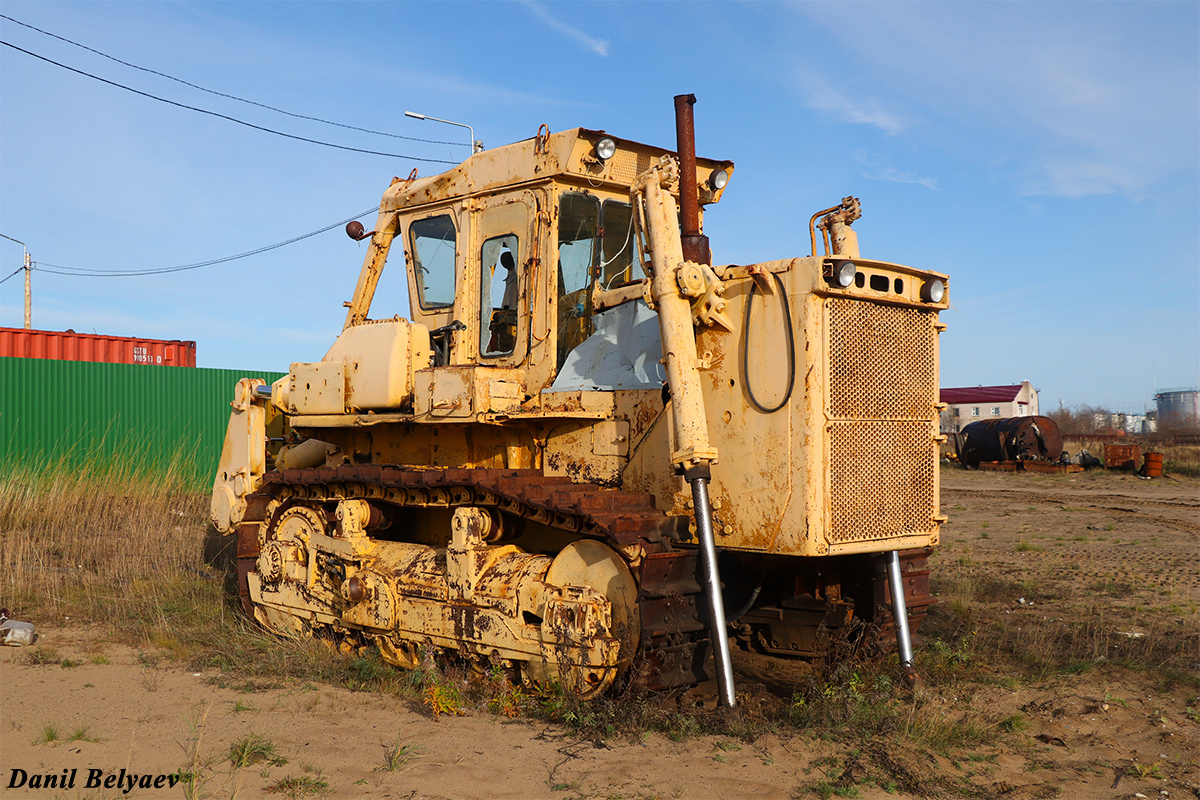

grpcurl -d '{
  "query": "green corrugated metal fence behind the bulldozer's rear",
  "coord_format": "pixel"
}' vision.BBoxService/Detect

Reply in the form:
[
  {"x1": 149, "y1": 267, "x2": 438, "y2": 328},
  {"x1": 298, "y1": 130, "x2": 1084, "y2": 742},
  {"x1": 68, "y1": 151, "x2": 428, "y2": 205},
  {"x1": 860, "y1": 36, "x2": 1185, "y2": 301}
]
[{"x1": 0, "y1": 357, "x2": 282, "y2": 491}]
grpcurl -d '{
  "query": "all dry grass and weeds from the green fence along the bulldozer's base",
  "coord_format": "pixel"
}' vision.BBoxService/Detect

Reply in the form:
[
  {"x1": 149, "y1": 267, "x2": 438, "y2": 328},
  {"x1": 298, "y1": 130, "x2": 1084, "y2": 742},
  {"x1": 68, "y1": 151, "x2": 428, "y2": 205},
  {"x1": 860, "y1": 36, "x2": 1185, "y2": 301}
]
[{"x1": 7, "y1": 455, "x2": 1194, "y2": 796}]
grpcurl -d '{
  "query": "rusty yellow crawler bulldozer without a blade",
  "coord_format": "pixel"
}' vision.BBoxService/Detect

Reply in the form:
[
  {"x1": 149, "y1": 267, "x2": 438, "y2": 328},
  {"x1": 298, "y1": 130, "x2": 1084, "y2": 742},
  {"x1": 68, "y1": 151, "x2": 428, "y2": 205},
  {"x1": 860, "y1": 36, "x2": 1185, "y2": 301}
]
[{"x1": 212, "y1": 95, "x2": 948, "y2": 705}]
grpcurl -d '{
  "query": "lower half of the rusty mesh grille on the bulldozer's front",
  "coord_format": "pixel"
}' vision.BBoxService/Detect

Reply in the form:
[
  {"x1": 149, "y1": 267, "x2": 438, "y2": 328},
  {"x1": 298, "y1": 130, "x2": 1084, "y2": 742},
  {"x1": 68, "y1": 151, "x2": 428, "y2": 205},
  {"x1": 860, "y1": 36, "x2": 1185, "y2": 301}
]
[{"x1": 829, "y1": 421, "x2": 937, "y2": 543}]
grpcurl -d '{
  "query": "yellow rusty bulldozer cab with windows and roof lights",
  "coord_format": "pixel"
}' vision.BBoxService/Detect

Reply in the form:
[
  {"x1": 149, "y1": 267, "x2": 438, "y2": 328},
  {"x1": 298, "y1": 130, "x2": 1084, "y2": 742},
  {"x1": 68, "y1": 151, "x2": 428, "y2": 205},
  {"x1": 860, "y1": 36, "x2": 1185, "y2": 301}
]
[{"x1": 346, "y1": 128, "x2": 732, "y2": 395}]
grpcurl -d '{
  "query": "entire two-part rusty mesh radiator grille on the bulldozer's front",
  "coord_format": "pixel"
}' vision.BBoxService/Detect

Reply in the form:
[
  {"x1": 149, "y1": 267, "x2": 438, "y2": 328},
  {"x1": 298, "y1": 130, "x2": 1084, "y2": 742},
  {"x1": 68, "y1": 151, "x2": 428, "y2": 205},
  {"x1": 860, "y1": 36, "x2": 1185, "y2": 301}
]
[{"x1": 826, "y1": 297, "x2": 937, "y2": 543}]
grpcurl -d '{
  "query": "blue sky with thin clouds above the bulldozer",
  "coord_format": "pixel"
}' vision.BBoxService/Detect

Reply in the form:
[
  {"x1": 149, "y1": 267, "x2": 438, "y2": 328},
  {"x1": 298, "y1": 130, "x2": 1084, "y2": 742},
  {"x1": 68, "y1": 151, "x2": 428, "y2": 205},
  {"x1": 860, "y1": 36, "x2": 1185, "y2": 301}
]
[{"x1": 0, "y1": 0, "x2": 1200, "y2": 411}]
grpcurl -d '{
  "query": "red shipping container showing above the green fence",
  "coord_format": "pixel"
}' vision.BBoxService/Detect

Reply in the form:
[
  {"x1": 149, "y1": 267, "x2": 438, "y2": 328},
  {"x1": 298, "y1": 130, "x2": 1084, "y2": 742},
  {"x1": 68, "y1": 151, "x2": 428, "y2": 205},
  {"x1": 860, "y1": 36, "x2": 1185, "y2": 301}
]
[{"x1": 0, "y1": 327, "x2": 196, "y2": 367}]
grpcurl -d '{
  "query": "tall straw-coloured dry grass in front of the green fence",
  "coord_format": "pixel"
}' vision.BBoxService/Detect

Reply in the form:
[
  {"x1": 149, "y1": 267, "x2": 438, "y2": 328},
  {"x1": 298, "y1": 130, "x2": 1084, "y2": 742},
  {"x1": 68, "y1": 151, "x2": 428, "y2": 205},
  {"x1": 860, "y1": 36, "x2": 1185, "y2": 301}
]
[{"x1": 0, "y1": 467, "x2": 223, "y2": 638}]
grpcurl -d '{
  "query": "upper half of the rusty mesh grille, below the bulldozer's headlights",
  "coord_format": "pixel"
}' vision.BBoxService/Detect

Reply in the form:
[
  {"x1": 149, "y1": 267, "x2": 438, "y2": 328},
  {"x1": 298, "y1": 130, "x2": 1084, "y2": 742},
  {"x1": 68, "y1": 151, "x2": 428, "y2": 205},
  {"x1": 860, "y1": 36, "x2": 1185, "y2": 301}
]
[{"x1": 826, "y1": 297, "x2": 937, "y2": 420}]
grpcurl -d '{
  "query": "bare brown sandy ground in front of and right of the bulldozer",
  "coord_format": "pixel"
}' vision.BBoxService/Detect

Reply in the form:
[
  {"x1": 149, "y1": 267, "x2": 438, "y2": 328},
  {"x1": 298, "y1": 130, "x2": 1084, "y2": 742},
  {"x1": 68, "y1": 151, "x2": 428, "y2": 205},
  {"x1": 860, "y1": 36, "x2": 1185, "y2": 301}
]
[{"x1": 0, "y1": 470, "x2": 1200, "y2": 800}]
